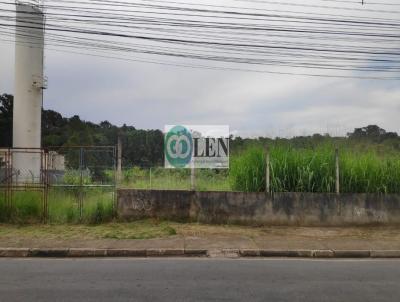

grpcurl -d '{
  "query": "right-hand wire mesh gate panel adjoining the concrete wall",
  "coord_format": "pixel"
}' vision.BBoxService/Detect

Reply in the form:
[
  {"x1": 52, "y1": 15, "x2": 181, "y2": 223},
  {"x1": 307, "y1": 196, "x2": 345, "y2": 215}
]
[{"x1": 48, "y1": 146, "x2": 116, "y2": 223}]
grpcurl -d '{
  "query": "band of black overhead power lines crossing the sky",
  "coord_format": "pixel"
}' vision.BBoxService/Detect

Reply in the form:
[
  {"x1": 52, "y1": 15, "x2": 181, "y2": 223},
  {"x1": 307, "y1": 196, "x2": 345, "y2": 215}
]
[{"x1": 0, "y1": 0, "x2": 400, "y2": 79}]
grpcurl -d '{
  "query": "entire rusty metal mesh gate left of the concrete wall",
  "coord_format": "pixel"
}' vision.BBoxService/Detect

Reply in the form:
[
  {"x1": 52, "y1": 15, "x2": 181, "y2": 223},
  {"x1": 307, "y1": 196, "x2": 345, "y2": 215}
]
[{"x1": 0, "y1": 146, "x2": 116, "y2": 222}]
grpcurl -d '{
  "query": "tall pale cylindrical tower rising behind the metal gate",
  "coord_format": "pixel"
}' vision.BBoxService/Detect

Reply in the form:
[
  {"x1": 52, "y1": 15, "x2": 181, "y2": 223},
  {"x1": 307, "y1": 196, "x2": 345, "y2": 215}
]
[{"x1": 13, "y1": 1, "x2": 47, "y2": 182}]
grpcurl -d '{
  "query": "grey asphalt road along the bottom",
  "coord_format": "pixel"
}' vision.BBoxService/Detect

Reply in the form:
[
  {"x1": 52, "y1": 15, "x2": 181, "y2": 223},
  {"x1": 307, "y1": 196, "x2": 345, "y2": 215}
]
[{"x1": 0, "y1": 259, "x2": 400, "y2": 302}]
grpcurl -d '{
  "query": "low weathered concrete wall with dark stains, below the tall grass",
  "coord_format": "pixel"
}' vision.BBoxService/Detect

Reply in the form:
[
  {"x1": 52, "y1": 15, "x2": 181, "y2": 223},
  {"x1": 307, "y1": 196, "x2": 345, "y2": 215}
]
[{"x1": 117, "y1": 189, "x2": 400, "y2": 226}]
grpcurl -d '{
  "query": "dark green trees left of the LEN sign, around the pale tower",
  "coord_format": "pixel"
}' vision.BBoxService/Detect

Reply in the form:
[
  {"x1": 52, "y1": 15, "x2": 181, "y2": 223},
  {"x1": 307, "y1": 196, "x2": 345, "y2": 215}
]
[{"x1": 0, "y1": 94, "x2": 163, "y2": 168}]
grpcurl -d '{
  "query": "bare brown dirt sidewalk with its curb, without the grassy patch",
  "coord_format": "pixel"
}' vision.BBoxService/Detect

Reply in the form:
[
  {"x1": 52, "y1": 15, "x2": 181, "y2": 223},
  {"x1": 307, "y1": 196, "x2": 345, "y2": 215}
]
[{"x1": 0, "y1": 223, "x2": 400, "y2": 258}]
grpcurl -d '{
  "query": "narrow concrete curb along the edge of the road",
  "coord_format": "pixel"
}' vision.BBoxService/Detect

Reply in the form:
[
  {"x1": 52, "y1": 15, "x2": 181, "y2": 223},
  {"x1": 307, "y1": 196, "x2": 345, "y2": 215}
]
[{"x1": 0, "y1": 248, "x2": 400, "y2": 258}]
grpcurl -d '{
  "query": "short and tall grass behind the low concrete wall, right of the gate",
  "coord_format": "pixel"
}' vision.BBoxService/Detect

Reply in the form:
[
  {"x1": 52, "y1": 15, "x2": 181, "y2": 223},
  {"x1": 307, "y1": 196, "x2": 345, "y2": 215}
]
[{"x1": 121, "y1": 145, "x2": 400, "y2": 194}]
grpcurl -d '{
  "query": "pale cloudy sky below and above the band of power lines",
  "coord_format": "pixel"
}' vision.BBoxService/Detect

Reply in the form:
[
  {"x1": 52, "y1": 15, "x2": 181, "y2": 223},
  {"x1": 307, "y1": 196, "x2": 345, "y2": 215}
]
[{"x1": 0, "y1": 0, "x2": 400, "y2": 137}]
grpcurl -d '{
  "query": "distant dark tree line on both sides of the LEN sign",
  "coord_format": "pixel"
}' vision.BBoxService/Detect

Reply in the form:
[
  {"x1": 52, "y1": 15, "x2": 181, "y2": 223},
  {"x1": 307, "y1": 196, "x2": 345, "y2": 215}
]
[{"x1": 0, "y1": 94, "x2": 400, "y2": 167}]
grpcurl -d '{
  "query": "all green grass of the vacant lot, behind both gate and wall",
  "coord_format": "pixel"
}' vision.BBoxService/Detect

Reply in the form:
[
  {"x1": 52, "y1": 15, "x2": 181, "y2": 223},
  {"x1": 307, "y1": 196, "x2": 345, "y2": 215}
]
[{"x1": 0, "y1": 146, "x2": 400, "y2": 224}]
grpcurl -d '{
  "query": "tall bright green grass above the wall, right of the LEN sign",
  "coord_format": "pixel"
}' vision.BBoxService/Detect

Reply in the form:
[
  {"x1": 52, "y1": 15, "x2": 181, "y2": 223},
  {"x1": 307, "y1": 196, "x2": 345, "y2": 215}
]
[{"x1": 230, "y1": 146, "x2": 400, "y2": 193}]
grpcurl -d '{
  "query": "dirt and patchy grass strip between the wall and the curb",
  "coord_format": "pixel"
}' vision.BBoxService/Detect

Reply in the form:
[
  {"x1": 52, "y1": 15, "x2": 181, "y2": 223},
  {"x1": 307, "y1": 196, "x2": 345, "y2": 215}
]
[{"x1": 0, "y1": 220, "x2": 400, "y2": 250}]
